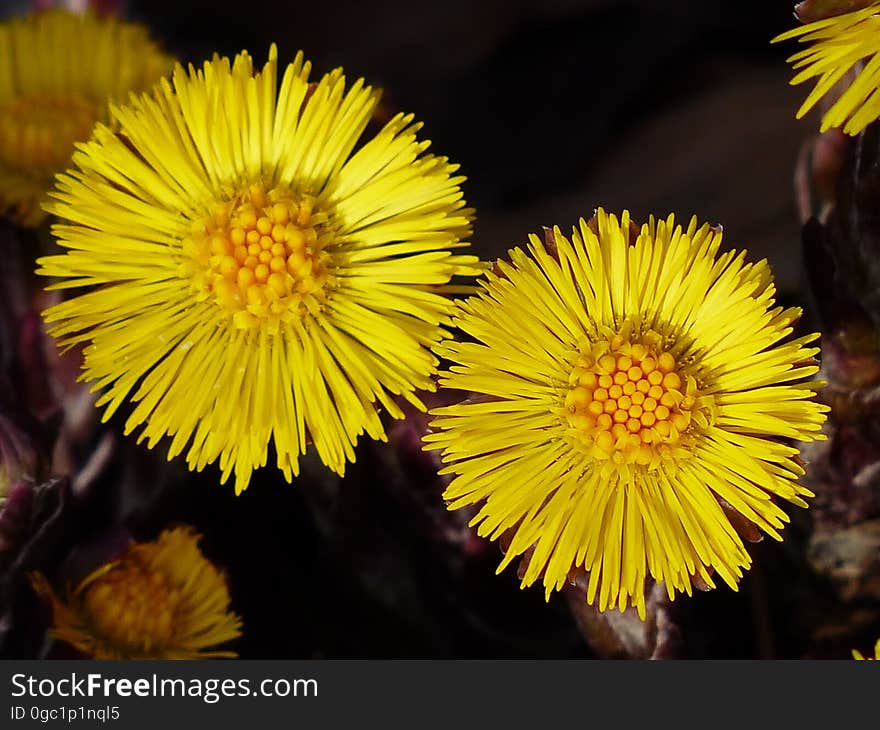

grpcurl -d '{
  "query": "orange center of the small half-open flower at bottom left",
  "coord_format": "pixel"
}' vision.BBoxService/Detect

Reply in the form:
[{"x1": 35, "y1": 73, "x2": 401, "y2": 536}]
[{"x1": 85, "y1": 557, "x2": 180, "y2": 652}]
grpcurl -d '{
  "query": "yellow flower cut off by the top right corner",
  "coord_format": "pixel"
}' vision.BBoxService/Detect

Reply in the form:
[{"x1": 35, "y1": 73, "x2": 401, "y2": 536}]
[{"x1": 773, "y1": 2, "x2": 880, "y2": 135}]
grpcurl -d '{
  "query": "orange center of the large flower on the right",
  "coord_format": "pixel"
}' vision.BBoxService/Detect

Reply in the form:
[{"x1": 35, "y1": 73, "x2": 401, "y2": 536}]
[{"x1": 565, "y1": 330, "x2": 697, "y2": 466}]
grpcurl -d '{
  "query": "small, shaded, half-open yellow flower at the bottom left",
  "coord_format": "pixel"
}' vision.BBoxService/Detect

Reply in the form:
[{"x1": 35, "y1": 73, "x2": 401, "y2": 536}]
[{"x1": 32, "y1": 527, "x2": 241, "y2": 659}]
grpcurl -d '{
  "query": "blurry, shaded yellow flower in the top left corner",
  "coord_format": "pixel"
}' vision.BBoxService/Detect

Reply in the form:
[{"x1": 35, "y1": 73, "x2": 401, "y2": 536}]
[{"x1": 0, "y1": 10, "x2": 171, "y2": 226}]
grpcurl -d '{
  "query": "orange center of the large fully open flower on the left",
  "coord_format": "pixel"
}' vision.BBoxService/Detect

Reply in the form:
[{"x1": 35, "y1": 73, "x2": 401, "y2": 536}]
[{"x1": 183, "y1": 185, "x2": 335, "y2": 332}]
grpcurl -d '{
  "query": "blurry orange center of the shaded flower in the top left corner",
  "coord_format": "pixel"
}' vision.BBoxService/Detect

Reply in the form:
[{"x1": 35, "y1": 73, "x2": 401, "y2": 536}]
[{"x1": 0, "y1": 95, "x2": 101, "y2": 178}]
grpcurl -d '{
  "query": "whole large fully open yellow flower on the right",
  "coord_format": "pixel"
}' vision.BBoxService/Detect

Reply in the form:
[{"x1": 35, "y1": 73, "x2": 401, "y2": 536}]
[{"x1": 425, "y1": 209, "x2": 826, "y2": 618}]
